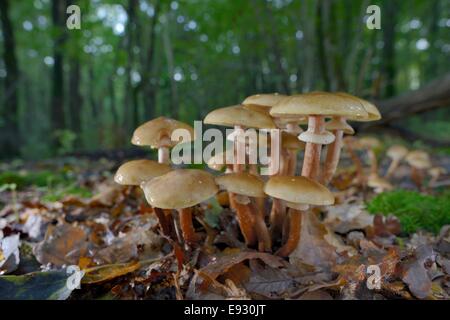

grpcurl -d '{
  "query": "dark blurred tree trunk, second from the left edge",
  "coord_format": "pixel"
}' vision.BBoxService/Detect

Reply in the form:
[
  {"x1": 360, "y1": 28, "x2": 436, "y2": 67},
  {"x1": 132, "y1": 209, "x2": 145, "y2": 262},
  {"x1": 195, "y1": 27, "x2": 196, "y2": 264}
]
[{"x1": 51, "y1": 0, "x2": 66, "y2": 137}]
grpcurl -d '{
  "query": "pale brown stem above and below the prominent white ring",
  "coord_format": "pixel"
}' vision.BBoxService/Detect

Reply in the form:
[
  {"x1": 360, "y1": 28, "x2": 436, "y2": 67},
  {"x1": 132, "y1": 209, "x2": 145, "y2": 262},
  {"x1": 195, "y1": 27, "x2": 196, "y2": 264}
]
[{"x1": 302, "y1": 116, "x2": 325, "y2": 180}]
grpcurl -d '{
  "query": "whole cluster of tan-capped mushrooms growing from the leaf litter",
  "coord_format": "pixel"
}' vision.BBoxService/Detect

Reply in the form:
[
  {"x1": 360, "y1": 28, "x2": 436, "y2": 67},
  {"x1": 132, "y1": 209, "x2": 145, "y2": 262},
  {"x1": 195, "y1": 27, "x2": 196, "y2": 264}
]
[{"x1": 115, "y1": 92, "x2": 382, "y2": 257}]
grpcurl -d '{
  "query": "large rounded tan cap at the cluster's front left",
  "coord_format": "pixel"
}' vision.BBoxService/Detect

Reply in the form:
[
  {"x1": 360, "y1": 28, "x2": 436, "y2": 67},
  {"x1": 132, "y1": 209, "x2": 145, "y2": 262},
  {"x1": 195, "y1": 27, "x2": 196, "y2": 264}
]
[{"x1": 142, "y1": 169, "x2": 219, "y2": 209}]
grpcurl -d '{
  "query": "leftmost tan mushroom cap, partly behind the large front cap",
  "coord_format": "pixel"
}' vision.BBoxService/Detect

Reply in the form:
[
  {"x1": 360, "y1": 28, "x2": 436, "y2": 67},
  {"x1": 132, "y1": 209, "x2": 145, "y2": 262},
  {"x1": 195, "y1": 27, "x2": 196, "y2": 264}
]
[{"x1": 114, "y1": 159, "x2": 172, "y2": 186}]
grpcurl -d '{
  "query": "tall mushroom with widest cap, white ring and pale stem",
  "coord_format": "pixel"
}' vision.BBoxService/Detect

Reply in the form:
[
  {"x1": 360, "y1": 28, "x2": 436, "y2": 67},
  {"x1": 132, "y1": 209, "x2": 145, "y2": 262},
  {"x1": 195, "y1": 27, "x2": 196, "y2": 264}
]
[{"x1": 270, "y1": 92, "x2": 367, "y2": 180}]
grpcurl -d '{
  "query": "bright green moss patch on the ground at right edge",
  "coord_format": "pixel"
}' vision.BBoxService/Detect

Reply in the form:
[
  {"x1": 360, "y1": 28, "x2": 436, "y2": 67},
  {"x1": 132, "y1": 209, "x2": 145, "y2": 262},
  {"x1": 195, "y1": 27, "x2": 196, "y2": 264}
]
[{"x1": 367, "y1": 190, "x2": 450, "y2": 233}]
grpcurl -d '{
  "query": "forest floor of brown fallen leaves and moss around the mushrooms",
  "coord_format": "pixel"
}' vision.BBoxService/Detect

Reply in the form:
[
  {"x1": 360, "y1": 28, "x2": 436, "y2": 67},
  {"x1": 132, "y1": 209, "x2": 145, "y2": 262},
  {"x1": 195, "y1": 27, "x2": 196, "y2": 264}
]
[{"x1": 0, "y1": 151, "x2": 450, "y2": 299}]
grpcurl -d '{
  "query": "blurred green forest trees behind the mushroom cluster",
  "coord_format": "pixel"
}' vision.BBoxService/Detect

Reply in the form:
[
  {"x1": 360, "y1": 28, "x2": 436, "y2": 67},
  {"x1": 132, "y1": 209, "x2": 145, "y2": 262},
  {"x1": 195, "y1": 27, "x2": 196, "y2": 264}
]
[{"x1": 0, "y1": 0, "x2": 450, "y2": 159}]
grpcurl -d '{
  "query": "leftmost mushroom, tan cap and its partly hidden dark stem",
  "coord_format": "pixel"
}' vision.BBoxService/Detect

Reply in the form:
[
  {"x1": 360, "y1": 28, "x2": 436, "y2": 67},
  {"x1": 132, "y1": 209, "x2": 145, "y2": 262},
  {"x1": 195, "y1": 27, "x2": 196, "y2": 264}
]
[{"x1": 114, "y1": 159, "x2": 172, "y2": 236}]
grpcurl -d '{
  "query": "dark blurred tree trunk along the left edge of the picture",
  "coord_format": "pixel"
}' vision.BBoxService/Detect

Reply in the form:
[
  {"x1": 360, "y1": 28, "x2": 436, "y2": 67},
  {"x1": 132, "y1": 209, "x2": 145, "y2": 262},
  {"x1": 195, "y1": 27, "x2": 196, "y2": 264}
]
[{"x1": 0, "y1": 0, "x2": 20, "y2": 156}]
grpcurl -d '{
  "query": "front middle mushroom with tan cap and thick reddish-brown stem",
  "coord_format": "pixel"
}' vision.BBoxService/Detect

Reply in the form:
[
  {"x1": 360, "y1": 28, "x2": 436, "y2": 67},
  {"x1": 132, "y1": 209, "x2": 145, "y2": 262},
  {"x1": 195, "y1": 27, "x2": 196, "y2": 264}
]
[{"x1": 216, "y1": 172, "x2": 272, "y2": 251}]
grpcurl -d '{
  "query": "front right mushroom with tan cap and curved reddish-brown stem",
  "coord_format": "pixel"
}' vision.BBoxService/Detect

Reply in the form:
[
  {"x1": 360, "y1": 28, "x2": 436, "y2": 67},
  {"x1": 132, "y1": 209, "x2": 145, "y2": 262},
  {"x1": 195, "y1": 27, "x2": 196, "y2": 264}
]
[{"x1": 264, "y1": 176, "x2": 334, "y2": 257}]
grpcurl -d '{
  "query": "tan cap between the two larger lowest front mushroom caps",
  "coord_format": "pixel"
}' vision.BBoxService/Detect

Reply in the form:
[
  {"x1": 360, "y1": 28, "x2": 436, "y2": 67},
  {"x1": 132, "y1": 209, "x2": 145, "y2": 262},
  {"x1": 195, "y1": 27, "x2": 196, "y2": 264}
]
[{"x1": 216, "y1": 172, "x2": 266, "y2": 198}]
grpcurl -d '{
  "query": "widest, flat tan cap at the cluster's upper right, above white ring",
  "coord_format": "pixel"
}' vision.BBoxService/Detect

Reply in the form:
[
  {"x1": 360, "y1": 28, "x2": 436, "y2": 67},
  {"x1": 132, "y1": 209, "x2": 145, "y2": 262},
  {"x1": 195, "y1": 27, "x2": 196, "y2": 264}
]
[{"x1": 270, "y1": 91, "x2": 367, "y2": 119}]
